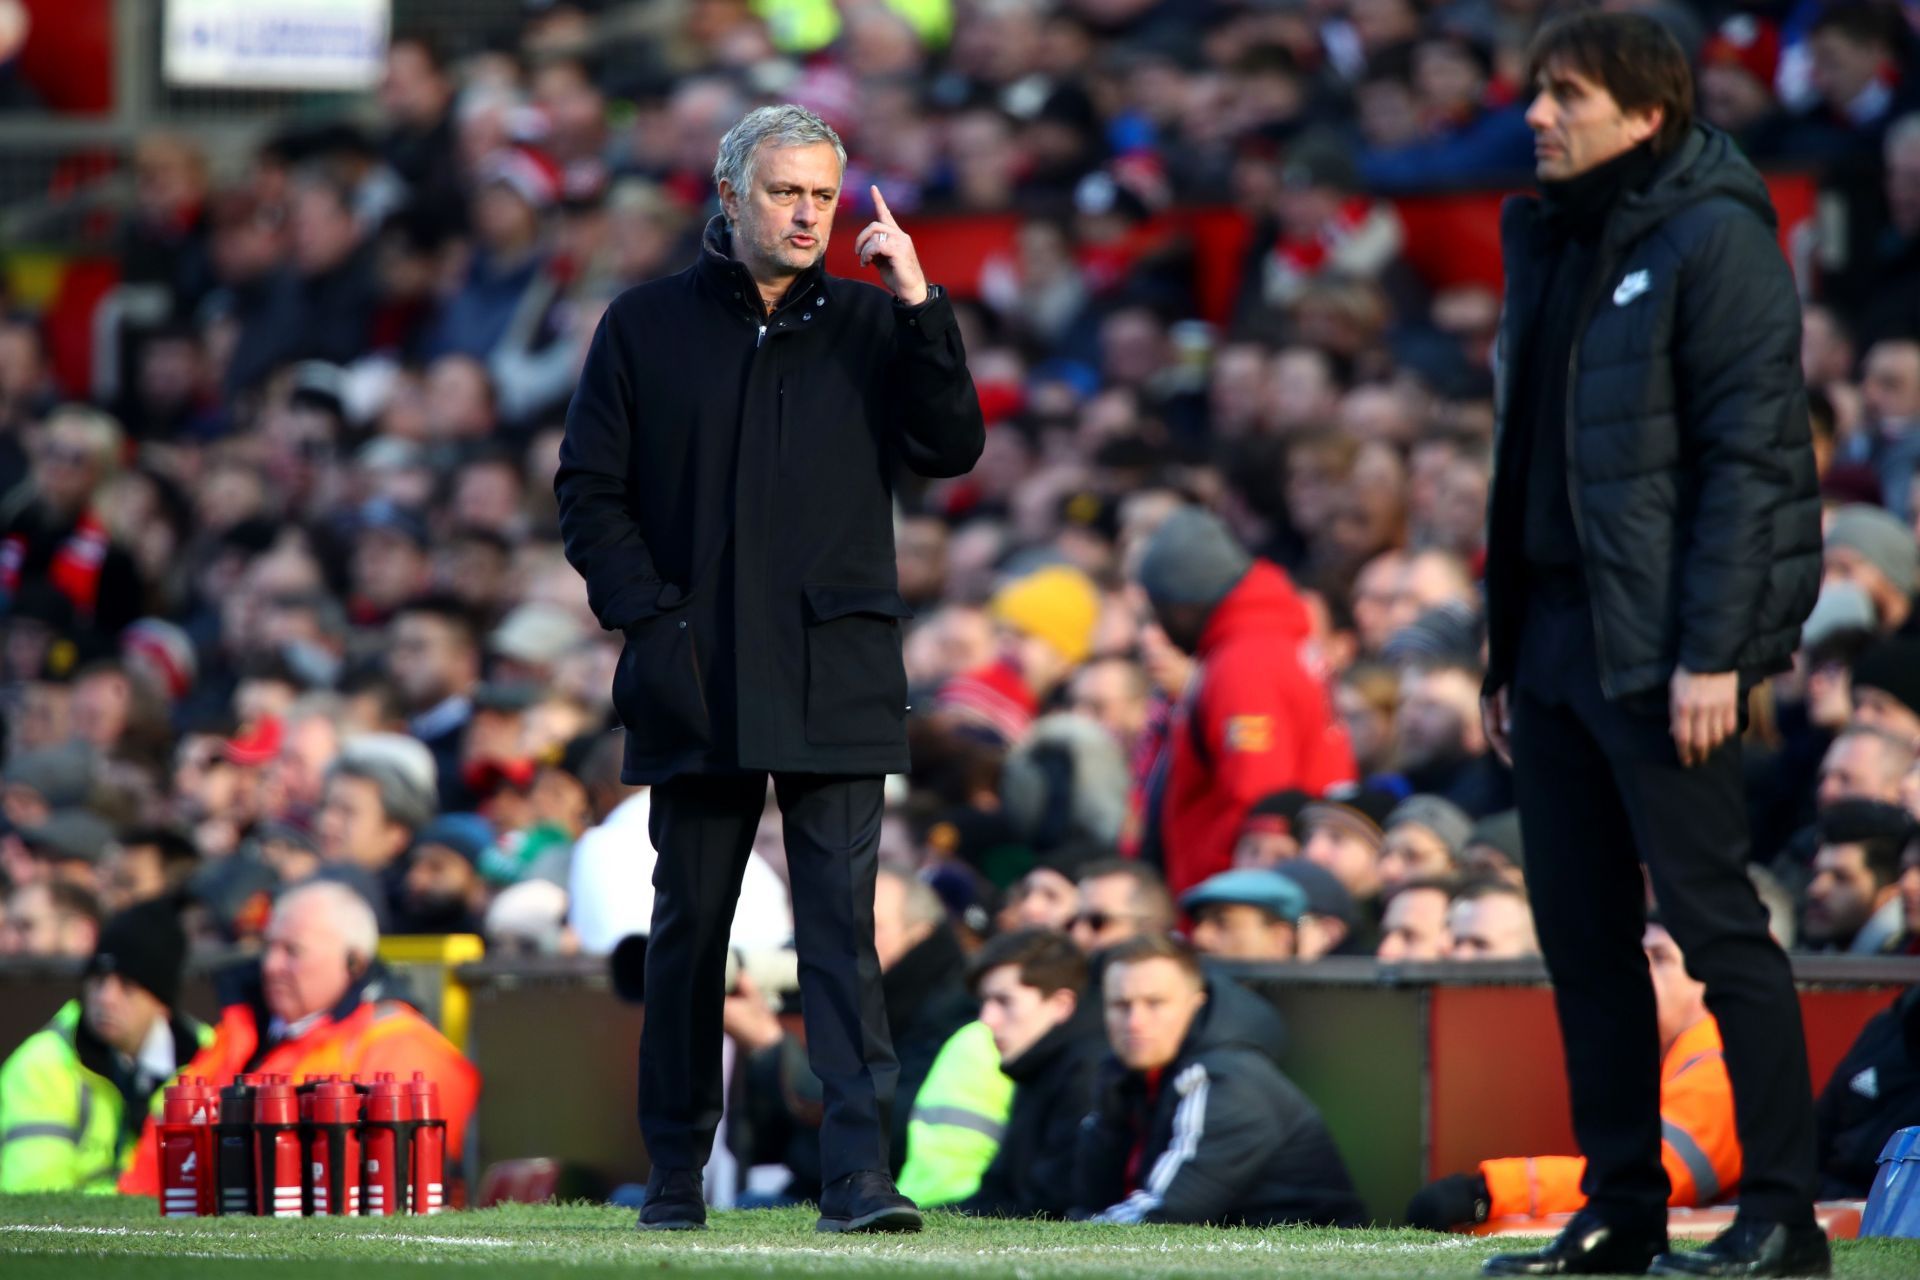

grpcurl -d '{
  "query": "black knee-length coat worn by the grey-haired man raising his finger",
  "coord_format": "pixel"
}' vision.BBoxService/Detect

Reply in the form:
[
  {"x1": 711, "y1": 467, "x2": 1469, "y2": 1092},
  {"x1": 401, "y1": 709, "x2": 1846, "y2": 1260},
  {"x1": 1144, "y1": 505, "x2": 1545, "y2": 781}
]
[{"x1": 555, "y1": 219, "x2": 985, "y2": 783}]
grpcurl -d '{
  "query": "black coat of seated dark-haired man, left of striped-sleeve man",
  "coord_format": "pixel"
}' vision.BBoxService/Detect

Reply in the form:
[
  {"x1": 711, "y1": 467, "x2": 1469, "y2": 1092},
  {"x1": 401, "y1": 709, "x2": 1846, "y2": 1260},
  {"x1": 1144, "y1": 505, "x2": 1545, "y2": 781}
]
[{"x1": 954, "y1": 988, "x2": 1106, "y2": 1219}]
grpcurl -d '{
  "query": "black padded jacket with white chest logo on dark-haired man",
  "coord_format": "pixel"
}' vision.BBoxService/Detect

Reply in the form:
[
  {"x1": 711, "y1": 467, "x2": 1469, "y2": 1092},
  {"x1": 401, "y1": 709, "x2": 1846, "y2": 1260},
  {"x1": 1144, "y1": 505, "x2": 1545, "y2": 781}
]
[{"x1": 1486, "y1": 125, "x2": 1820, "y2": 699}]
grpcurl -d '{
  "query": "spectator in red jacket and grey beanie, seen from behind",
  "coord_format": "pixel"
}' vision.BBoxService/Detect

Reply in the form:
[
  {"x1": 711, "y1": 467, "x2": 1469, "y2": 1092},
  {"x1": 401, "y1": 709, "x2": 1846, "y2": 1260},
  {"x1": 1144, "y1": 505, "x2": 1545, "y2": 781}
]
[{"x1": 1137, "y1": 510, "x2": 1363, "y2": 896}]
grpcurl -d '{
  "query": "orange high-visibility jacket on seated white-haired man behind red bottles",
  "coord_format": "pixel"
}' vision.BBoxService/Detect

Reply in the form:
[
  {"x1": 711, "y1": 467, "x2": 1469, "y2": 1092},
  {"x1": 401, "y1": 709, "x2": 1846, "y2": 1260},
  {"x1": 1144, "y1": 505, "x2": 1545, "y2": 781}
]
[{"x1": 119, "y1": 1000, "x2": 480, "y2": 1196}]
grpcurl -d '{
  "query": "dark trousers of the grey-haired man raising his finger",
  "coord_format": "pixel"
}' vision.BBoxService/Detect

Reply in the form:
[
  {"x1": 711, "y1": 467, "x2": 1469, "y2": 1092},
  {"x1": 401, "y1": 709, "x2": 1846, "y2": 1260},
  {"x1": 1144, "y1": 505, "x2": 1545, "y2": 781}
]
[{"x1": 639, "y1": 773, "x2": 899, "y2": 1184}]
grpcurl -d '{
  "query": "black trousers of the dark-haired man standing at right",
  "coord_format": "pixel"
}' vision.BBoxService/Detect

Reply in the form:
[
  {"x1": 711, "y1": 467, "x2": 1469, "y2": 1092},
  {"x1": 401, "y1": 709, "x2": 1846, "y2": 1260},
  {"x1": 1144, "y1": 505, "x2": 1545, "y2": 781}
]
[{"x1": 1511, "y1": 599, "x2": 1814, "y2": 1224}]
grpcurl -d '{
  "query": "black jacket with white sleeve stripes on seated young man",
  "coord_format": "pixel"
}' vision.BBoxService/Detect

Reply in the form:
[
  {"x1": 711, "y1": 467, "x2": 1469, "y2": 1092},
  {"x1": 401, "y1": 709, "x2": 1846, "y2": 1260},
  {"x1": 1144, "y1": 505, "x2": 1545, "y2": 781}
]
[{"x1": 1073, "y1": 977, "x2": 1363, "y2": 1226}]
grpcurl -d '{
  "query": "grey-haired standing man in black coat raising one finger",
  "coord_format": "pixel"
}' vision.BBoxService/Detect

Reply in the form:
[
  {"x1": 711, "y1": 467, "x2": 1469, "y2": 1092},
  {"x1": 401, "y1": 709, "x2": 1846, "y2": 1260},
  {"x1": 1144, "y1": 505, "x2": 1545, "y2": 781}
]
[{"x1": 555, "y1": 106, "x2": 985, "y2": 1230}]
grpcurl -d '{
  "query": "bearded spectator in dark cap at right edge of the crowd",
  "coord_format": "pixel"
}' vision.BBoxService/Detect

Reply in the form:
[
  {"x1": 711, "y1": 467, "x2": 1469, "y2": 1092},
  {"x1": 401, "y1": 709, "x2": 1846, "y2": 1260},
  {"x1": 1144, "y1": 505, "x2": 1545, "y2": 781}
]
[{"x1": 1801, "y1": 800, "x2": 1914, "y2": 956}]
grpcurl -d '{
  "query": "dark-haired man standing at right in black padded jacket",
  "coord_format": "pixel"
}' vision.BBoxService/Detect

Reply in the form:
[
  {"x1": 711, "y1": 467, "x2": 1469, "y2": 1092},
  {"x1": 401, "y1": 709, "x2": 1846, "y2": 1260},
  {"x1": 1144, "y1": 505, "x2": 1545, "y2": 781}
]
[{"x1": 1482, "y1": 13, "x2": 1828, "y2": 1276}]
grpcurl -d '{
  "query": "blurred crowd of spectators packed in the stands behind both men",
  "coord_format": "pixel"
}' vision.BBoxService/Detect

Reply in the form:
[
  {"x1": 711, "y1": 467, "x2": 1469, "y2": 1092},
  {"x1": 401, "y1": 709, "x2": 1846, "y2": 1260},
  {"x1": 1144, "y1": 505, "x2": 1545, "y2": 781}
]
[{"x1": 0, "y1": 0, "x2": 1920, "y2": 1221}]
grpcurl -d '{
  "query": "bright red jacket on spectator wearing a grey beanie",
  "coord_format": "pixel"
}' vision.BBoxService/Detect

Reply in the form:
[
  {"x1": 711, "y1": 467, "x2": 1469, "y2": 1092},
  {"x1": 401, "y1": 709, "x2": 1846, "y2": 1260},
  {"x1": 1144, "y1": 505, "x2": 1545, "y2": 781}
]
[{"x1": 1137, "y1": 560, "x2": 1356, "y2": 898}]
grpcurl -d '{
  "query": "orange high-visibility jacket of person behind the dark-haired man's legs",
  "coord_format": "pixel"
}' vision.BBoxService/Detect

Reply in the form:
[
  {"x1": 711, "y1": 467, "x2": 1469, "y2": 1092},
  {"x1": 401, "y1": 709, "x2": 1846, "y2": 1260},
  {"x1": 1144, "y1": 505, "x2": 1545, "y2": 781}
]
[{"x1": 1480, "y1": 1017, "x2": 1740, "y2": 1219}]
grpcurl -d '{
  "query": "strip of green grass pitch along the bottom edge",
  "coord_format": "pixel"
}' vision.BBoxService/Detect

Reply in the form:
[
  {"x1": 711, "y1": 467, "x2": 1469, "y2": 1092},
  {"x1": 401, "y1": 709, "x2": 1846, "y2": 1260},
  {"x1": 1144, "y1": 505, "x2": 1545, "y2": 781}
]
[{"x1": 0, "y1": 1196, "x2": 1920, "y2": 1280}]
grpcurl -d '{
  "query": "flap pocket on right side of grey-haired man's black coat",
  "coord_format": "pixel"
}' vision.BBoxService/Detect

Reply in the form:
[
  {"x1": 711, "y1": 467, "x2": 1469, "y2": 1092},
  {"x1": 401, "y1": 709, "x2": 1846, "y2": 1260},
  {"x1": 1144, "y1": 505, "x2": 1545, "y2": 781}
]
[{"x1": 803, "y1": 585, "x2": 914, "y2": 747}]
